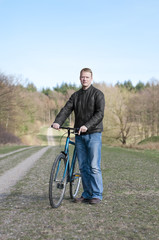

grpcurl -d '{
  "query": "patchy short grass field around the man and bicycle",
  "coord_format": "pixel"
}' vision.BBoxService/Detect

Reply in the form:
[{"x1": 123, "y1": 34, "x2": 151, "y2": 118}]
[{"x1": 0, "y1": 143, "x2": 159, "y2": 240}]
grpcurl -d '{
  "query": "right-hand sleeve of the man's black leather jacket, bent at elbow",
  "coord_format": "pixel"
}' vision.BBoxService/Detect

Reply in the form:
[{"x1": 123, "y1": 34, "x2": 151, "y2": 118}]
[{"x1": 85, "y1": 92, "x2": 105, "y2": 129}]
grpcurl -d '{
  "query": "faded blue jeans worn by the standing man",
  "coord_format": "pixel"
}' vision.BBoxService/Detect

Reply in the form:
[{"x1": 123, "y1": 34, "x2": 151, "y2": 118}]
[{"x1": 75, "y1": 133, "x2": 103, "y2": 200}]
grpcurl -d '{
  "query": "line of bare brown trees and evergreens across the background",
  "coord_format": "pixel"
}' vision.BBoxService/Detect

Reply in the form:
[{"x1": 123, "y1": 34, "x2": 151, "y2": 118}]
[{"x1": 0, "y1": 73, "x2": 159, "y2": 144}]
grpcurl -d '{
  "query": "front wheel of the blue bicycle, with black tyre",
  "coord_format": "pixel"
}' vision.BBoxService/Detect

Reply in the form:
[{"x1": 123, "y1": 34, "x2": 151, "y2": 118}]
[{"x1": 49, "y1": 153, "x2": 67, "y2": 208}]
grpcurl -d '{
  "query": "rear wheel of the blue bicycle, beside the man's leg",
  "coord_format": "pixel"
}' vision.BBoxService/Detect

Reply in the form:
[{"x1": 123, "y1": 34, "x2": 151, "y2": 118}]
[{"x1": 70, "y1": 157, "x2": 81, "y2": 199}]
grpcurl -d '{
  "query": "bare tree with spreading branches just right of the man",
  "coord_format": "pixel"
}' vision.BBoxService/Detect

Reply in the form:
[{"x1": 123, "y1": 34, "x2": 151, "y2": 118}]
[{"x1": 96, "y1": 84, "x2": 131, "y2": 144}]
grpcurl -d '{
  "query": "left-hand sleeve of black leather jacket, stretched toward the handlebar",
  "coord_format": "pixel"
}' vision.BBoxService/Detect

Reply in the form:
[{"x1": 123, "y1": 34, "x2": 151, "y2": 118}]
[{"x1": 54, "y1": 95, "x2": 73, "y2": 126}]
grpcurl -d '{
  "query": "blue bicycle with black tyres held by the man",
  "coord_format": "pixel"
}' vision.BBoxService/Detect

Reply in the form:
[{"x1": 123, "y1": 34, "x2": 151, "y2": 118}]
[{"x1": 49, "y1": 126, "x2": 81, "y2": 208}]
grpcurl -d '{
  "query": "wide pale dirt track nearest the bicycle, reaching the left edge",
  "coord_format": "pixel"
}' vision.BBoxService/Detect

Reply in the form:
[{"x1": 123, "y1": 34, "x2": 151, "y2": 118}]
[{"x1": 0, "y1": 146, "x2": 50, "y2": 197}]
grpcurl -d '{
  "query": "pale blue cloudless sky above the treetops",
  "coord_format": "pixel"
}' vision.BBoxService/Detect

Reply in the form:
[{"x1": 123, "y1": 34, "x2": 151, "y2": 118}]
[{"x1": 0, "y1": 0, "x2": 159, "y2": 90}]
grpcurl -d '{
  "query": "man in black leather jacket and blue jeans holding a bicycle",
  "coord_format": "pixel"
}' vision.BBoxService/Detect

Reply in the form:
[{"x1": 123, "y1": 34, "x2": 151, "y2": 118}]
[{"x1": 53, "y1": 68, "x2": 105, "y2": 204}]
